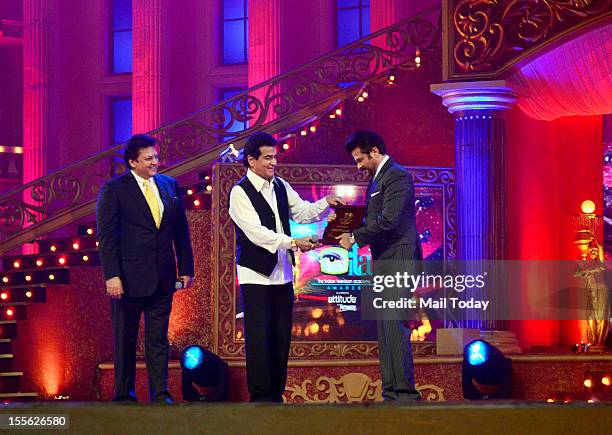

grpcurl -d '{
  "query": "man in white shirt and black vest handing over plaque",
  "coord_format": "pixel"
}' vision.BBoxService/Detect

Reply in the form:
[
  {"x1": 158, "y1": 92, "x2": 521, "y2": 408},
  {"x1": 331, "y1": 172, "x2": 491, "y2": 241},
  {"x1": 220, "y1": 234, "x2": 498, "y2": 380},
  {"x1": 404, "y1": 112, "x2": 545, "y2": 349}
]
[{"x1": 229, "y1": 133, "x2": 344, "y2": 402}]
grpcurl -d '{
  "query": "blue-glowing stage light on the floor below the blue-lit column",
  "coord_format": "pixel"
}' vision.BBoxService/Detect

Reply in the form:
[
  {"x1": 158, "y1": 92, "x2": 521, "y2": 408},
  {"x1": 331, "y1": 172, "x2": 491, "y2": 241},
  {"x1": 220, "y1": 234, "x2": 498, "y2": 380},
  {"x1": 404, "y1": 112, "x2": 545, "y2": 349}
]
[{"x1": 461, "y1": 340, "x2": 512, "y2": 400}]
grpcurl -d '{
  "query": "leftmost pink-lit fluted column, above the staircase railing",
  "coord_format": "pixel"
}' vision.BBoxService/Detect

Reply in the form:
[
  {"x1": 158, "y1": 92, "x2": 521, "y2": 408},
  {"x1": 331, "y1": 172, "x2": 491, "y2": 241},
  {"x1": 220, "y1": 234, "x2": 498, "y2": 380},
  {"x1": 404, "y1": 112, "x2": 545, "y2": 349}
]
[{"x1": 23, "y1": 0, "x2": 54, "y2": 184}]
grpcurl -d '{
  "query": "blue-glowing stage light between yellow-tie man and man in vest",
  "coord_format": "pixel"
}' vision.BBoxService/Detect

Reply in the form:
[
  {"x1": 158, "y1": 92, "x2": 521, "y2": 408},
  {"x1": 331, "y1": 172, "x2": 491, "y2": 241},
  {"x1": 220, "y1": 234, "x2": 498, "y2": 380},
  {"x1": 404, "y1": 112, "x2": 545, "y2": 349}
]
[{"x1": 179, "y1": 346, "x2": 228, "y2": 402}]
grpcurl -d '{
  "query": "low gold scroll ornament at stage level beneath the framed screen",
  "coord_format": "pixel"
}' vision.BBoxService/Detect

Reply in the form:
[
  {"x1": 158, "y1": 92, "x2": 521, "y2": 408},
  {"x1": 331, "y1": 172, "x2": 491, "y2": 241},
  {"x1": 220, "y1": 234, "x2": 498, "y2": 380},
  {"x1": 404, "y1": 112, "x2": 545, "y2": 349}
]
[{"x1": 283, "y1": 372, "x2": 446, "y2": 403}]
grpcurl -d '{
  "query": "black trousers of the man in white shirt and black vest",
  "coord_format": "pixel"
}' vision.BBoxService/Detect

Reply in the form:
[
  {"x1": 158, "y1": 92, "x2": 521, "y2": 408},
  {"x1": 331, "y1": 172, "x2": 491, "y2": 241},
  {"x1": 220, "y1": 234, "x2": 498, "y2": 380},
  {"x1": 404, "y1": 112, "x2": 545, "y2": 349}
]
[{"x1": 240, "y1": 282, "x2": 293, "y2": 402}]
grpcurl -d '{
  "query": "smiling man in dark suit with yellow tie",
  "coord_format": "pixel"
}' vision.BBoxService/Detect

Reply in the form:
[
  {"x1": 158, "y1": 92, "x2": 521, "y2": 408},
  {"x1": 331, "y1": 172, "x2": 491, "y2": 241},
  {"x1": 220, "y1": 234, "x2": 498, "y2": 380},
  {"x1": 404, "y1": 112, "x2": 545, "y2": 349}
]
[{"x1": 96, "y1": 134, "x2": 193, "y2": 403}]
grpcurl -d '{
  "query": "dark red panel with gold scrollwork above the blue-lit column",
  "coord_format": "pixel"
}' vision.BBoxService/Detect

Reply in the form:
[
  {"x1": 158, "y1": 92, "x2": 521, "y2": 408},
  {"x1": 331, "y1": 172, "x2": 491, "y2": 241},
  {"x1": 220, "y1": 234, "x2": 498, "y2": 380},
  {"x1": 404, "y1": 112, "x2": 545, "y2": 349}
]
[{"x1": 444, "y1": 0, "x2": 612, "y2": 80}]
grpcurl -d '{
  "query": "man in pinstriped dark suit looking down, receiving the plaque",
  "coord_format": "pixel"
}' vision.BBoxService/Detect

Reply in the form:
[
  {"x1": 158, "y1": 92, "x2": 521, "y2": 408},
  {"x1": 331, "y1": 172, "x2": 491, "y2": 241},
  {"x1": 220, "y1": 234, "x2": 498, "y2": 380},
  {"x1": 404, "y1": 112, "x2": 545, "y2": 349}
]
[{"x1": 338, "y1": 130, "x2": 422, "y2": 403}]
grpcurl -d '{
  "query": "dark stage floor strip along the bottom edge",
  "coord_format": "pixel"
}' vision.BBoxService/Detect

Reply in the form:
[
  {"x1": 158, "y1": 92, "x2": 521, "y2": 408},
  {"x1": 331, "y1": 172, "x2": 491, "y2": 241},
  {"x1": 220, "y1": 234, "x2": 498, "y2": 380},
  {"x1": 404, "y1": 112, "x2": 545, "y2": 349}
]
[{"x1": 0, "y1": 402, "x2": 612, "y2": 435}]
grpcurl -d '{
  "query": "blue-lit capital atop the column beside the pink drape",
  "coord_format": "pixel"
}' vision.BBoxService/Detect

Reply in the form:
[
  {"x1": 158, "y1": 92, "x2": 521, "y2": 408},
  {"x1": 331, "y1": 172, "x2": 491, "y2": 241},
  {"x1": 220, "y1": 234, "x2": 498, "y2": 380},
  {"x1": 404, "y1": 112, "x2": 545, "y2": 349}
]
[{"x1": 430, "y1": 80, "x2": 518, "y2": 114}]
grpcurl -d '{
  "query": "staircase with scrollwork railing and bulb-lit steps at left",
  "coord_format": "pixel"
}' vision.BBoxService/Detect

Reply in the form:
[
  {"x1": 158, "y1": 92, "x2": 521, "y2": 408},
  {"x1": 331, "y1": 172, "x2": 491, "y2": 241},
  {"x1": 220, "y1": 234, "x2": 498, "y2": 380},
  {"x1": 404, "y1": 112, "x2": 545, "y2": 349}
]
[{"x1": 0, "y1": 6, "x2": 441, "y2": 401}]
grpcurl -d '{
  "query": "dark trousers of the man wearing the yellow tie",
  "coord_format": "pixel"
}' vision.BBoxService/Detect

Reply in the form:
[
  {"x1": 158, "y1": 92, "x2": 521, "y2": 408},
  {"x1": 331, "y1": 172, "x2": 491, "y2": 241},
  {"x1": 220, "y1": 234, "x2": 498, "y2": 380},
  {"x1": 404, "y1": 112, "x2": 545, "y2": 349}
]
[{"x1": 111, "y1": 288, "x2": 174, "y2": 400}]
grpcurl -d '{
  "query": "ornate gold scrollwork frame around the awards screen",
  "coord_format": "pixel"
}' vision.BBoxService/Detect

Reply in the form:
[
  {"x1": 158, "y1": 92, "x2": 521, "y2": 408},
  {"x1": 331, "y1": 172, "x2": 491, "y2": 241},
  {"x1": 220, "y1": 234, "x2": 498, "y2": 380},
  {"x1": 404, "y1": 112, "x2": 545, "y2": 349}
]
[{"x1": 211, "y1": 163, "x2": 456, "y2": 361}]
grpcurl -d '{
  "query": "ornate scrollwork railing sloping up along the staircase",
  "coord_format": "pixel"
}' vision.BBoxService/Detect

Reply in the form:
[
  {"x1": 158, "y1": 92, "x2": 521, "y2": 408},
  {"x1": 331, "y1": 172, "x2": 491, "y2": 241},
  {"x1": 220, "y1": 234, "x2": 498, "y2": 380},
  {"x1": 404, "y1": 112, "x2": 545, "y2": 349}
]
[{"x1": 0, "y1": 6, "x2": 441, "y2": 254}]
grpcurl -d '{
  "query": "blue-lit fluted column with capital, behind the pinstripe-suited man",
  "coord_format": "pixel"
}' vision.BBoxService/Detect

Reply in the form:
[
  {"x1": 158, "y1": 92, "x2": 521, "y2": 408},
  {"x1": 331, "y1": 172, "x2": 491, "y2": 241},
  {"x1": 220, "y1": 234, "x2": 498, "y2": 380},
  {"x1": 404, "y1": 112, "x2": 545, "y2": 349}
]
[{"x1": 431, "y1": 80, "x2": 517, "y2": 329}]
